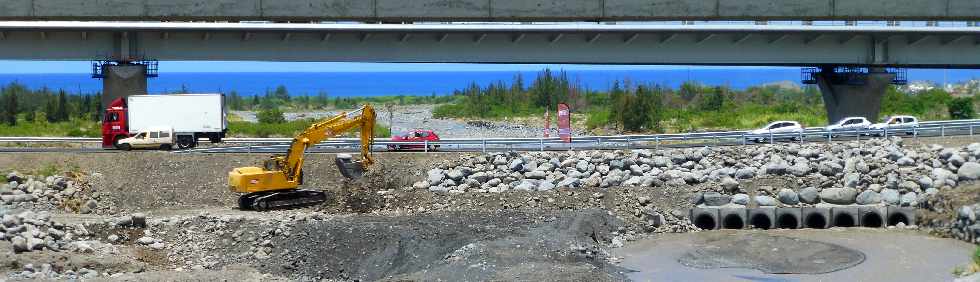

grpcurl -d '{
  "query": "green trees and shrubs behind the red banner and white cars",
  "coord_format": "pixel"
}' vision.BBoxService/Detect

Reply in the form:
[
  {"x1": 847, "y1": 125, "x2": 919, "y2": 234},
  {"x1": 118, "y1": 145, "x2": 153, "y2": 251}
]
[{"x1": 434, "y1": 69, "x2": 976, "y2": 132}]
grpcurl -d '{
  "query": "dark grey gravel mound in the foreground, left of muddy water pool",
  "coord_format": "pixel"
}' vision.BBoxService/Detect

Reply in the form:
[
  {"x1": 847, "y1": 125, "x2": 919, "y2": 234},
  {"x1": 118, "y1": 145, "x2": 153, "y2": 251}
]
[{"x1": 259, "y1": 210, "x2": 620, "y2": 281}]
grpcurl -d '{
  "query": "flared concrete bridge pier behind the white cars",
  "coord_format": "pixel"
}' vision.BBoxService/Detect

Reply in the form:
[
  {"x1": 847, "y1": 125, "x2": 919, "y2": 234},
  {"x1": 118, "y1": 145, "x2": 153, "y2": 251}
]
[{"x1": 814, "y1": 67, "x2": 895, "y2": 123}]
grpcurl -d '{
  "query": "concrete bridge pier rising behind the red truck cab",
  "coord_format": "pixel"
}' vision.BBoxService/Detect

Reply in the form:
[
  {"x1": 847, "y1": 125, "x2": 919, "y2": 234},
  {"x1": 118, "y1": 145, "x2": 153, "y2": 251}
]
[{"x1": 102, "y1": 63, "x2": 147, "y2": 106}]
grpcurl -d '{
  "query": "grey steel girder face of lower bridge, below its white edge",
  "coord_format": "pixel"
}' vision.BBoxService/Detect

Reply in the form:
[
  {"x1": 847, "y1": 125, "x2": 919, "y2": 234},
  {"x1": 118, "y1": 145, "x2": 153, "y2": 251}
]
[{"x1": 0, "y1": 30, "x2": 980, "y2": 68}]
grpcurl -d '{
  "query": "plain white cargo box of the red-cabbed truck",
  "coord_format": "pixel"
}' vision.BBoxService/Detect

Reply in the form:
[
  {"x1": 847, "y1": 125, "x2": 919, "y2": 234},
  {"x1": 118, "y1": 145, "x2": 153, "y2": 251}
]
[{"x1": 126, "y1": 94, "x2": 228, "y2": 133}]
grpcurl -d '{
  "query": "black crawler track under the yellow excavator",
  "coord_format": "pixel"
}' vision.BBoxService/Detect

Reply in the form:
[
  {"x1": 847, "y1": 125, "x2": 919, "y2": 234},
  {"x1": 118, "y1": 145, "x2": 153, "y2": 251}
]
[{"x1": 238, "y1": 189, "x2": 327, "y2": 211}]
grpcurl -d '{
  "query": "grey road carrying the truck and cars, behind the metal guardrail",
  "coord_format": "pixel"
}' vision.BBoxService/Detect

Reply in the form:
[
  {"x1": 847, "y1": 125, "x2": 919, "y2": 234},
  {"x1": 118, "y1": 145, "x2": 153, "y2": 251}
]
[{"x1": 0, "y1": 121, "x2": 980, "y2": 154}]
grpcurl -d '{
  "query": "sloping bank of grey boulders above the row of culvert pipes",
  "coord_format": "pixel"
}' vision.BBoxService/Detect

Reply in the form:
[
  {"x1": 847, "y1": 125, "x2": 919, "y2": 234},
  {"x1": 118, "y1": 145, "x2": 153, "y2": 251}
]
[{"x1": 412, "y1": 137, "x2": 980, "y2": 210}]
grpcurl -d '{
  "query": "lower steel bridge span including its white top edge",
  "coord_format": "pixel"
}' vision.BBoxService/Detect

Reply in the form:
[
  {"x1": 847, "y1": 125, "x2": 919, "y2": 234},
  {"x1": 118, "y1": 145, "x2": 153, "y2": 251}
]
[{"x1": 0, "y1": 22, "x2": 980, "y2": 68}]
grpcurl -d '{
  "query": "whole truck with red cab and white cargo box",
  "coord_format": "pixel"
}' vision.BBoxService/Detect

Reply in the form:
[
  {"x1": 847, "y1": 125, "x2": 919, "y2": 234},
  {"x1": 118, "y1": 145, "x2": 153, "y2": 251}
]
[{"x1": 102, "y1": 94, "x2": 228, "y2": 148}]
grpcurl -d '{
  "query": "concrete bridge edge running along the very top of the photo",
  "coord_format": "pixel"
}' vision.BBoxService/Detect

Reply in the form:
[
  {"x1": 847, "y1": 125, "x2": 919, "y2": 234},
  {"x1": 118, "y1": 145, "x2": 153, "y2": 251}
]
[{"x1": 0, "y1": 0, "x2": 980, "y2": 22}]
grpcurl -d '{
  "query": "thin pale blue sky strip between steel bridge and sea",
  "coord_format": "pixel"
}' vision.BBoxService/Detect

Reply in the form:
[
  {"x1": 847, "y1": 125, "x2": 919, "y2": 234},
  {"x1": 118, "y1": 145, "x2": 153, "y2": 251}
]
[{"x1": 0, "y1": 60, "x2": 784, "y2": 74}]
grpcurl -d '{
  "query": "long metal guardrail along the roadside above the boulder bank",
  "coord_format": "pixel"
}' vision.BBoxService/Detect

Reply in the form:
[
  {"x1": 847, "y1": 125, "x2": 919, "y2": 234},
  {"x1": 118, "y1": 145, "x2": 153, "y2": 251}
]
[{"x1": 0, "y1": 119, "x2": 980, "y2": 152}]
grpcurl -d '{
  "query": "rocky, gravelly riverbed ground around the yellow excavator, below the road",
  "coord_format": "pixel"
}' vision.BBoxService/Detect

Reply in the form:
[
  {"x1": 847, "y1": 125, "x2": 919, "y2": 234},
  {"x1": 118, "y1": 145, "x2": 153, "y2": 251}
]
[{"x1": 0, "y1": 136, "x2": 980, "y2": 281}]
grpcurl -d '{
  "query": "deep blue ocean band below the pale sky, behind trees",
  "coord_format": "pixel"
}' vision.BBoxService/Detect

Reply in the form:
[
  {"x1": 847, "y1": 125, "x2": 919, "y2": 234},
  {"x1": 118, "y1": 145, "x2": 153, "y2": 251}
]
[{"x1": 0, "y1": 67, "x2": 980, "y2": 97}]
